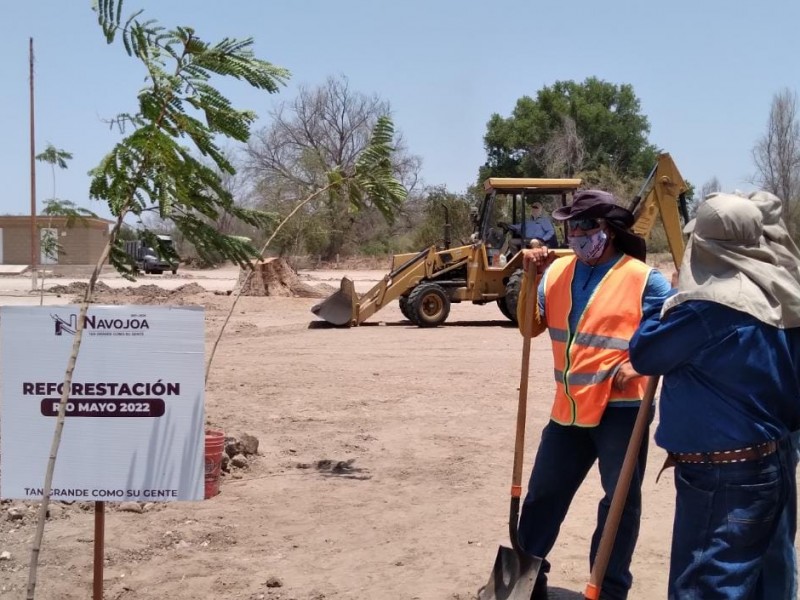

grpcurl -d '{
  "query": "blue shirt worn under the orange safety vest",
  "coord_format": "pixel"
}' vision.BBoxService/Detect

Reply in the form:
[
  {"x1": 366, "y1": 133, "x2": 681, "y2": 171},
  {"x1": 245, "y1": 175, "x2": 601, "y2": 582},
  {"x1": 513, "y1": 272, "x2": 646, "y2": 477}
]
[{"x1": 538, "y1": 254, "x2": 673, "y2": 408}]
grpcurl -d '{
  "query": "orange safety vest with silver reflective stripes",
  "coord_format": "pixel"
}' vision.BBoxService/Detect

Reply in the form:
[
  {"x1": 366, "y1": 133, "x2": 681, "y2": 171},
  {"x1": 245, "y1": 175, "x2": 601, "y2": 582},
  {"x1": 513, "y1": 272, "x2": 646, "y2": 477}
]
[{"x1": 545, "y1": 255, "x2": 651, "y2": 427}]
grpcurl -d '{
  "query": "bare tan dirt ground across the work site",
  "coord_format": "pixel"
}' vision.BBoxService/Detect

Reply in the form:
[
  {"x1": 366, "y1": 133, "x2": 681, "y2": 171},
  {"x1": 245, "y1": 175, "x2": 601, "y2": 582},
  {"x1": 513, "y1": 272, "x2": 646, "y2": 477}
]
[{"x1": 0, "y1": 269, "x2": 796, "y2": 600}]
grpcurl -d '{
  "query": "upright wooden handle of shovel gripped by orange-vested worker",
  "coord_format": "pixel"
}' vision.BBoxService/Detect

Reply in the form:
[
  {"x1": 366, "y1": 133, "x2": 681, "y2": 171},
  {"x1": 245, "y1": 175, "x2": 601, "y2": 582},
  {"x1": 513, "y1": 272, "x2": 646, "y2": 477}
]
[{"x1": 508, "y1": 262, "x2": 537, "y2": 552}]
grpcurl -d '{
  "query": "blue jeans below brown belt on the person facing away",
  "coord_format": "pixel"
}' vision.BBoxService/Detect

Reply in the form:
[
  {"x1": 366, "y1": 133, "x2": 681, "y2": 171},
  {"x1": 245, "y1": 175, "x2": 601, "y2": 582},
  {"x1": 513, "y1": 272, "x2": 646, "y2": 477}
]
[{"x1": 669, "y1": 440, "x2": 795, "y2": 600}]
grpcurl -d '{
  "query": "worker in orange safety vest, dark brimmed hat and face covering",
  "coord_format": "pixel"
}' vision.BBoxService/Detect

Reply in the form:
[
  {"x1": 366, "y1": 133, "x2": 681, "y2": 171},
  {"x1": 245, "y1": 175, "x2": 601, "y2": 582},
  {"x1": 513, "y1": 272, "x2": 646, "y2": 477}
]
[{"x1": 517, "y1": 190, "x2": 671, "y2": 600}]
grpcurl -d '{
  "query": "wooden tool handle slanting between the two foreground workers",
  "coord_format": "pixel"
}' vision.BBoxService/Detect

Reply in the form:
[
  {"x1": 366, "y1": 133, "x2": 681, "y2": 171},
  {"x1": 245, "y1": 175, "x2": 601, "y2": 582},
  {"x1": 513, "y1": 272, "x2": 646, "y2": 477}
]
[{"x1": 583, "y1": 377, "x2": 658, "y2": 600}]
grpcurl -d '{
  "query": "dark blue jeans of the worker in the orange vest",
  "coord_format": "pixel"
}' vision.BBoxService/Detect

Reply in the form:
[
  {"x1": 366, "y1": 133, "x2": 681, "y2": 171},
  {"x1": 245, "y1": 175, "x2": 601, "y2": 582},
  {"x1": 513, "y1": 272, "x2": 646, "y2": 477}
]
[{"x1": 519, "y1": 407, "x2": 648, "y2": 600}]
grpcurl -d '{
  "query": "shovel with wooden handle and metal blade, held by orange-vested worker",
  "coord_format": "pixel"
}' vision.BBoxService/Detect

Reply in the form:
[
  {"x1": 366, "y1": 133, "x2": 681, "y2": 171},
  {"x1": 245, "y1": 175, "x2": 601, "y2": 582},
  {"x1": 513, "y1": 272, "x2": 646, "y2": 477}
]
[{"x1": 478, "y1": 264, "x2": 542, "y2": 600}]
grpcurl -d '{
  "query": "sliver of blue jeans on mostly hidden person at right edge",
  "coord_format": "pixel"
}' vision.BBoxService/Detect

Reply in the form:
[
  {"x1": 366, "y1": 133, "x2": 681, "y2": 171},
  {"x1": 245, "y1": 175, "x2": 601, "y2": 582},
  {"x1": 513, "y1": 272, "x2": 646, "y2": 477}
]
[{"x1": 761, "y1": 431, "x2": 800, "y2": 600}]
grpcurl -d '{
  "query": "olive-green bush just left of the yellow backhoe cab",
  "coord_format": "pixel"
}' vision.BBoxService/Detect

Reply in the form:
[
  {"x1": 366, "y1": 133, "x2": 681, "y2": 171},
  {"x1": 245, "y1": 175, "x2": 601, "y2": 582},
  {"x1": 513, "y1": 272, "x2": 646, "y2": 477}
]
[{"x1": 414, "y1": 187, "x2": 472, "y2": 250}]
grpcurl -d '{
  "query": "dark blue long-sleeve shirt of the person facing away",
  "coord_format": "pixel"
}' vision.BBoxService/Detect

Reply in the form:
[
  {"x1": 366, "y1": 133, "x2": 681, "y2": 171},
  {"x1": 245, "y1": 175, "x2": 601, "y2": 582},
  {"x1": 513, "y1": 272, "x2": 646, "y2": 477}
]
[{"x1": 629, "y1": 301, "x2": 800, "y2": 452}]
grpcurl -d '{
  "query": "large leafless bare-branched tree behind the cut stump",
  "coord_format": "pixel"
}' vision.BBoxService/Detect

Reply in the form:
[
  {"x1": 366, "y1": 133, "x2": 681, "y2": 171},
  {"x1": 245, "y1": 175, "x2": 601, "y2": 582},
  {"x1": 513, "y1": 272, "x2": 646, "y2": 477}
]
[{"x1": 245, "y1": 77, "x2": 421, "y2": 260}]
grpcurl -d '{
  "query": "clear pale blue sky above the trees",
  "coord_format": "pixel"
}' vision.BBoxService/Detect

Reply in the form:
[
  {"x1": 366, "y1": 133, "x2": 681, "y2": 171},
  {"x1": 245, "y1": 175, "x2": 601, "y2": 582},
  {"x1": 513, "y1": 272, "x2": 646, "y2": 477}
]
[{"x1": 0, "y1": 0, "x2": 800, "y2": 220}]
